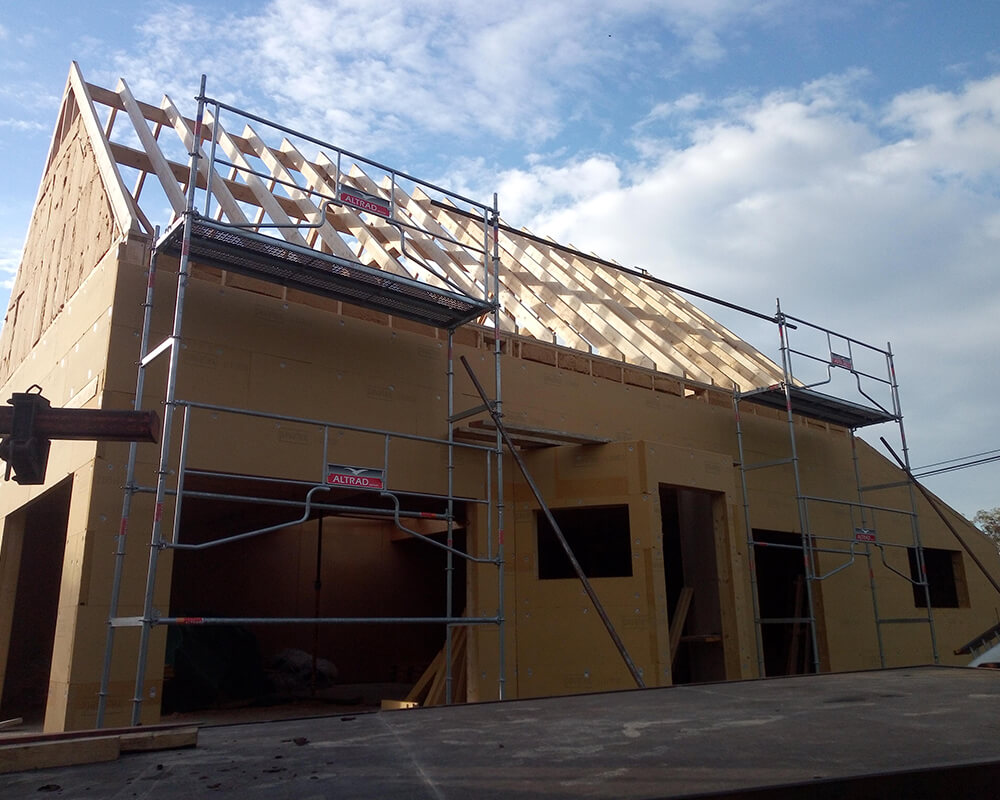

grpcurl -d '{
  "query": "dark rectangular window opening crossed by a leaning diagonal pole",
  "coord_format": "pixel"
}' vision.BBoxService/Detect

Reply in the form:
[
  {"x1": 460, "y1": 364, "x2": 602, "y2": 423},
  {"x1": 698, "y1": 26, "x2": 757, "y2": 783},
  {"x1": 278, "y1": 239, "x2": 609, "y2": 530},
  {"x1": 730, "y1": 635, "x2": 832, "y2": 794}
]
[{"x1": 535, "y1": 506, "x2": 632, "y2": 580}]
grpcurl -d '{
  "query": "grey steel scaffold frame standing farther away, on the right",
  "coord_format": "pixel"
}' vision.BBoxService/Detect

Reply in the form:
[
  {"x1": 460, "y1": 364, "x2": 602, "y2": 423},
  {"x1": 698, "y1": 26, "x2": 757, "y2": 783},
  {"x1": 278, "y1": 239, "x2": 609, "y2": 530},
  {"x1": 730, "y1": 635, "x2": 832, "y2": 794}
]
[{"x1": 733, "y1": 300, "x2": 939, "y2": 676}]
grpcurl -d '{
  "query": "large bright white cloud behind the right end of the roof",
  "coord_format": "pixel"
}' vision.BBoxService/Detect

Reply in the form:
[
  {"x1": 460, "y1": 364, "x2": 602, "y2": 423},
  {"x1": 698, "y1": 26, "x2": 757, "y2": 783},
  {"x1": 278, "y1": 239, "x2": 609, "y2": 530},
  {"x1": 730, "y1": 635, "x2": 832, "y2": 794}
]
[{"x1": 490, "y1": 75, "x2": 1000, "y2": 514}]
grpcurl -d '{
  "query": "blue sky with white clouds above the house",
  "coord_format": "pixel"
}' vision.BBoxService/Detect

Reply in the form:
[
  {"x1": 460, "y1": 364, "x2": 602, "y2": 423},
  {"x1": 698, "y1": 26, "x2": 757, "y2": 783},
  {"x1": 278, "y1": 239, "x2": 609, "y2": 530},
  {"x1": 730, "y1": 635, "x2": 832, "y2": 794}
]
[{"x1": 0, "y1": 0, "x2": 1000, "y2": 515}]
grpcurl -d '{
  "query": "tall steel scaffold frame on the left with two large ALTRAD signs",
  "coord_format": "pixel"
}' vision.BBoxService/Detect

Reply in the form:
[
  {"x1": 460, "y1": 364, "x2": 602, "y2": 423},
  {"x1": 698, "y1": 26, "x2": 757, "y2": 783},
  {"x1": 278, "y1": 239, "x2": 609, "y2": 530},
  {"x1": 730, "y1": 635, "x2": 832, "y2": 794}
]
[{"x1": 96, "y1": 75, "x2": 506, "y2": 728}]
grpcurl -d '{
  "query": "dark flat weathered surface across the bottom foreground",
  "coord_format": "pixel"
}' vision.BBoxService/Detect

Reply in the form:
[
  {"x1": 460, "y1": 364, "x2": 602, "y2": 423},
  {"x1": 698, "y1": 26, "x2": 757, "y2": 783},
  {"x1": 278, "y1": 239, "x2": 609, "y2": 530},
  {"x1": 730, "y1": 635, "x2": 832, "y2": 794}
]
[{"x1": 0, "y1": 667, "x2": 1000, "y2": 800}]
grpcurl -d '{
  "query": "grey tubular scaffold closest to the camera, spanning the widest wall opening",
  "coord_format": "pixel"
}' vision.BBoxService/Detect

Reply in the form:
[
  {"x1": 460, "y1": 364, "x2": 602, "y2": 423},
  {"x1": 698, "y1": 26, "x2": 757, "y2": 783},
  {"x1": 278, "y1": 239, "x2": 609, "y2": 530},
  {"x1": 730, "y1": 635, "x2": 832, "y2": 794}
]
[{"x1": 108, "y1": 75, "x2": 506, "y2": 726}]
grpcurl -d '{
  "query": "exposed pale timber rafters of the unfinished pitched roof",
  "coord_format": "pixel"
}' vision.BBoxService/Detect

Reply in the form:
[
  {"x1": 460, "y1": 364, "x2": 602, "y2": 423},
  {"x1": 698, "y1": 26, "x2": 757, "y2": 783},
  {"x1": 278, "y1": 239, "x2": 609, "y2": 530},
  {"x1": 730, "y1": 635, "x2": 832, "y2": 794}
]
[{"x1": 3, "y1": 63, "x2": 782, "y2": 389}]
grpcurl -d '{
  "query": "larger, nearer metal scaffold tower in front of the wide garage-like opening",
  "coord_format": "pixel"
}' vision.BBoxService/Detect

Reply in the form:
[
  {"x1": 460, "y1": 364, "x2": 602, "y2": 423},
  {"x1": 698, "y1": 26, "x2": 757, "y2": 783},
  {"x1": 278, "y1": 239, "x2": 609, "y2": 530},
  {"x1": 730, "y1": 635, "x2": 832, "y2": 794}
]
[{"x1": 97, "y1": 76, "x2": 505, "y2": 727}]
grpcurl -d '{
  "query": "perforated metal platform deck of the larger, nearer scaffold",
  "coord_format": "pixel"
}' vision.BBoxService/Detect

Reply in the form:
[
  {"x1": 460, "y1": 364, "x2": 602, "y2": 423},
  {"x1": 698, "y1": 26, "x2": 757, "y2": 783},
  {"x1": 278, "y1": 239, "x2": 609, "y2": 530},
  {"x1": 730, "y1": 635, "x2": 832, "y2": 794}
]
[{"x1": 159, "y1": 216, "x2": 492, "y2": 328}]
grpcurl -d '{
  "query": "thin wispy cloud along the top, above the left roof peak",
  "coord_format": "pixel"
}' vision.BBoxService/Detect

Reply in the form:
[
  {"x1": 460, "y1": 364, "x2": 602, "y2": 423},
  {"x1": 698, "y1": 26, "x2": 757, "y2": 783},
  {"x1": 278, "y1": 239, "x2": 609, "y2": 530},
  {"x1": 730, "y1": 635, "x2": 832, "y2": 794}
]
[{"x1": 99, "y1": 0, "x2": 804, "y2": 158}]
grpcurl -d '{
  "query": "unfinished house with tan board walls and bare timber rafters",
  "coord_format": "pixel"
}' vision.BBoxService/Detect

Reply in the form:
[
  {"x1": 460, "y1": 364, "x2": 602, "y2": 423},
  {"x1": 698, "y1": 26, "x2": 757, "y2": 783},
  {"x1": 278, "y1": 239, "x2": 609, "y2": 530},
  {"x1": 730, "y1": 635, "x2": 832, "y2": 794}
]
[{"x1": 0, "y1": 64, "x2": 997, "y2": 730}]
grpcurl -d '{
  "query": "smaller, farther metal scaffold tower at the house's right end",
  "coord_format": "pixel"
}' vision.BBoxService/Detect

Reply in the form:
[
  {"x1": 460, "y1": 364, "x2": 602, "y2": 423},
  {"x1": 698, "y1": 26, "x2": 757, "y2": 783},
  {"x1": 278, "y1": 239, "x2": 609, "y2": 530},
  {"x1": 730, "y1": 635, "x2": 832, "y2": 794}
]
[{"x1": 733, "y1": 300, "x2": 939, "y2": 676}]
